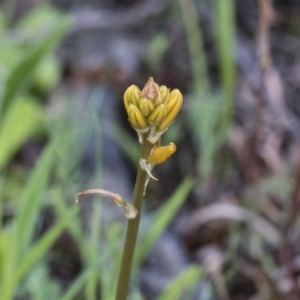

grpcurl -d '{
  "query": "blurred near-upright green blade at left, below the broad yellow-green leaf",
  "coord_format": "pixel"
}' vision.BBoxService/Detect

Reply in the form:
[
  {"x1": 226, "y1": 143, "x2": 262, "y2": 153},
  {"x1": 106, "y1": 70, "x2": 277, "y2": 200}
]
[{"x1": 14, "y1": 144, "x2": 54, "y2": 259}]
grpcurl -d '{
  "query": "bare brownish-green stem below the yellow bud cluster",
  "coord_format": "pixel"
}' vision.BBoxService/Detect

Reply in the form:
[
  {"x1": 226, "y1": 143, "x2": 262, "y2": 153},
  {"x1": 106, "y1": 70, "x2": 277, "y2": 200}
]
[{"x1": 115, "y1": 138, "x2": 153, "y2": 300}]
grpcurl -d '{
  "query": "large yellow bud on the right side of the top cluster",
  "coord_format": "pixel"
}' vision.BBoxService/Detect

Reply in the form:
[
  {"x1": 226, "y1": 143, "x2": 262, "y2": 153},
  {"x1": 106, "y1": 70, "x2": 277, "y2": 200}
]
[{"x1": 156, "y1": 89, "x2": 183, "y2": 131}]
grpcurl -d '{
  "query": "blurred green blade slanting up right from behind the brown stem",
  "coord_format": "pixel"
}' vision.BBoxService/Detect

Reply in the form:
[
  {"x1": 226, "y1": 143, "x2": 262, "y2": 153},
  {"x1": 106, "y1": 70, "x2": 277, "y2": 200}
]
[{"x1": 135, "y1": 178, "x2": 195, "y2": 267}]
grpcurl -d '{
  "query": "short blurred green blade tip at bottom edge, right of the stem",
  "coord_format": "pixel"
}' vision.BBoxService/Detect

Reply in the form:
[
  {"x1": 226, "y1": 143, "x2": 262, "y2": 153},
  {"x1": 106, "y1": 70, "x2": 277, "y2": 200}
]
[{"x1": 157, "y1": 265, "x2": 202, "y2": 300}]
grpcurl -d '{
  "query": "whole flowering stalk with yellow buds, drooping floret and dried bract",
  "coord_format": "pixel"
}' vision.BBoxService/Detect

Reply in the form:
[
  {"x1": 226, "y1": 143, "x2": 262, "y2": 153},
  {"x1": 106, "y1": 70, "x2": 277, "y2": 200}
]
[{"x1": 77, "y1": 77, "x2": 183, "y2": 300}]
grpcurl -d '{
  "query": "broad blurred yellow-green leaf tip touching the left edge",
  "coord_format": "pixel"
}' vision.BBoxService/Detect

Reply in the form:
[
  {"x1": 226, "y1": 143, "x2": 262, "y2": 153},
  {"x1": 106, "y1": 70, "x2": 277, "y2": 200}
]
[{"x1": 0, "y1": 98, "x2": 43, "y2": 171}]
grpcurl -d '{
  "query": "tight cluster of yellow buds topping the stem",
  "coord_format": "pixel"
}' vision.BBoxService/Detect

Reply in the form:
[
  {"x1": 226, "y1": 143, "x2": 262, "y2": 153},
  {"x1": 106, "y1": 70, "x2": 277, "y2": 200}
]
[{"x1": 124, "y1": 77, "x2": 183, "y2": 144}]
